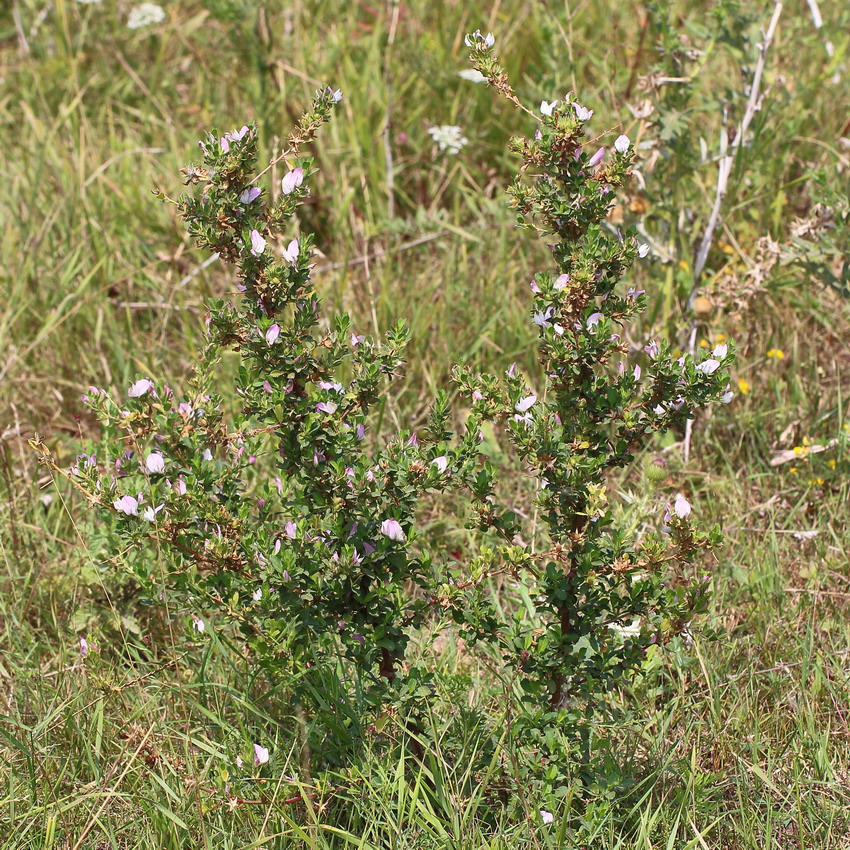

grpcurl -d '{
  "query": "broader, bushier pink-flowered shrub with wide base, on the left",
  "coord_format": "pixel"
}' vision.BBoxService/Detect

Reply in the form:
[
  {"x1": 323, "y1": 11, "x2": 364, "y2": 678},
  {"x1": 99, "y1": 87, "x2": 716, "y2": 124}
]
[{"x1": 36, "y1": 88, "x2": 477, "y2": 724}]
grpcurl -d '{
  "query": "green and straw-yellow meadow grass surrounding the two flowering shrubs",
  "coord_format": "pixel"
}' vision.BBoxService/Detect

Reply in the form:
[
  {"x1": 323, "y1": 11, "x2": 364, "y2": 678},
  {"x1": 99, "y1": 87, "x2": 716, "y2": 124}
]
[{"x1": 0, "y1": 0, "x2": 850, "y2": 850}]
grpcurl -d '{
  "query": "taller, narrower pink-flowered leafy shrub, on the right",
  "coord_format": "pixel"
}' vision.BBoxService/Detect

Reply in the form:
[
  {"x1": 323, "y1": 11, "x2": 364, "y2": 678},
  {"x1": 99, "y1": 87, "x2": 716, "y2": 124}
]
[{"x1": 456, "y1": 32, "x2": 733, "y2": 760}]
